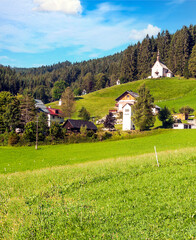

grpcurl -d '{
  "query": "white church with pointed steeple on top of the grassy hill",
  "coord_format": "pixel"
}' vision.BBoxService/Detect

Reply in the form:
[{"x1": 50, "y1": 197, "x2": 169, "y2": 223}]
[{"x1": 151, "y1": 51, "x2": 174, "y2": 78}]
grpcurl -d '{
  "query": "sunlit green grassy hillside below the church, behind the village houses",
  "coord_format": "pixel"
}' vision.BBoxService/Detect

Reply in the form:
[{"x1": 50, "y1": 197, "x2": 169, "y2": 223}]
[{"x1": 49, "y1": 77, "x2": 196, "y2": 117}]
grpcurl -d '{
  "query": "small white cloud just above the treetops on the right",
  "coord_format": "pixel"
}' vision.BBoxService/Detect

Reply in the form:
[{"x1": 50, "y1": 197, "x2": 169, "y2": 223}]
[{"x1": 130, "y1": 24, "x2": 161, "y2": 40}]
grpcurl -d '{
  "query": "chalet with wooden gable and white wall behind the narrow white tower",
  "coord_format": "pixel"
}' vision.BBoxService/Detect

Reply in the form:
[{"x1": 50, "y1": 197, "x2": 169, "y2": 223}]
[{"x1": 115, "y1": 91, "x2": 139, "y2": 113}]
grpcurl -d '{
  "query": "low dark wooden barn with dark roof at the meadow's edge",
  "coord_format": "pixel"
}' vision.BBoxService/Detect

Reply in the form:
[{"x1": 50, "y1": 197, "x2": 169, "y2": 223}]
[{"x1": 63, "y1": 119, "x2": 97, "y2": 133}]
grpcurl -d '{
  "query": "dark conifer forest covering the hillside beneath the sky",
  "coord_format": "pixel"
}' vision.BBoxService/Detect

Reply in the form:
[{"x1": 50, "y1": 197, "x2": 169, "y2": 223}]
[{"x1": 0, "y1": 25, "x2": 196, "y2": 102}]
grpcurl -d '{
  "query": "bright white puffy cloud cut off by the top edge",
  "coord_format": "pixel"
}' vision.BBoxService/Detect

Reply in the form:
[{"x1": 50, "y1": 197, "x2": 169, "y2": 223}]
[{"x1": 34, "y1": 0, "x2": 82, "y2": 14}]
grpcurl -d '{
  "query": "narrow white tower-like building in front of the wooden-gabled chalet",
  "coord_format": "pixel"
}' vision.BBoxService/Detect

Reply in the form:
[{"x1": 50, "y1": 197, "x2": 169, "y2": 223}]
[{"x1": 123, "y1": 103, "x2": 134, "y2": 131}]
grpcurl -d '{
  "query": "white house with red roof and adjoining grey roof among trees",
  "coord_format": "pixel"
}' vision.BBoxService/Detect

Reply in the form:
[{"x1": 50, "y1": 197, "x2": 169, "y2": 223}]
[{"x1": 35, "y1": 99, "x2": 64, "y2": 127}]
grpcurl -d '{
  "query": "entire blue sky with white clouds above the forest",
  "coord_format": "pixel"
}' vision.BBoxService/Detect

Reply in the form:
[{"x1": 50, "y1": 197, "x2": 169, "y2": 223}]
[{"x1": 0, "y1": 0, "x2": 196, "y2": 68}]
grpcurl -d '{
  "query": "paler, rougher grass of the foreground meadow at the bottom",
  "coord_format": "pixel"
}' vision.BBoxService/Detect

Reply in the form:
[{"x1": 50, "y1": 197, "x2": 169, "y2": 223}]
[{"x1": 0, "y1": 146, "x2": 196, "y2": 240}]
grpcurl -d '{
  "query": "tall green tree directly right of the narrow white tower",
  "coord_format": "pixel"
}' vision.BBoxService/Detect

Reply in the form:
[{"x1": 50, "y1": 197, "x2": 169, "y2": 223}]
[{"x1": 132, "y1": 84, "x2": 155, "y2": 131}]
